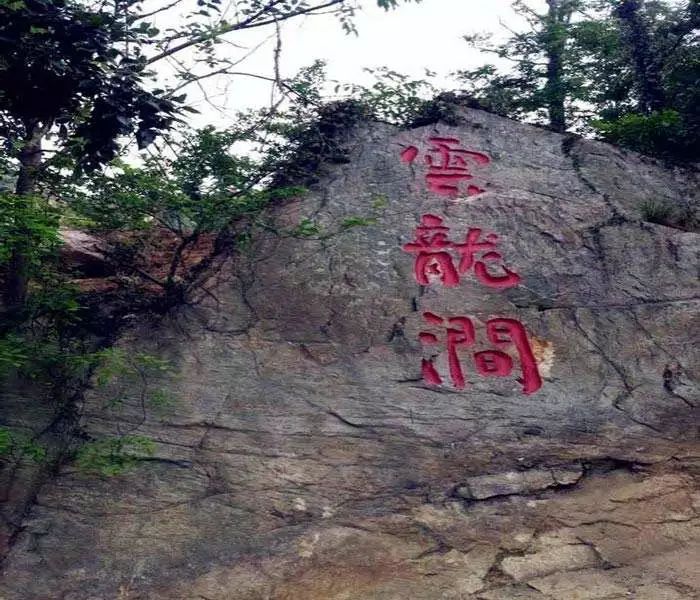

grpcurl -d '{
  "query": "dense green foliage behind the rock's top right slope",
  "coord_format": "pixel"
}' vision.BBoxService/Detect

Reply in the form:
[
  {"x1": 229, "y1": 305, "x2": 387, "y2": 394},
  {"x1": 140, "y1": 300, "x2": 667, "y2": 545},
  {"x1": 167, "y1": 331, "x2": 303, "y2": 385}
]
[{"x1": 458, "y1": 0, "x2": 700, "y2": 161}]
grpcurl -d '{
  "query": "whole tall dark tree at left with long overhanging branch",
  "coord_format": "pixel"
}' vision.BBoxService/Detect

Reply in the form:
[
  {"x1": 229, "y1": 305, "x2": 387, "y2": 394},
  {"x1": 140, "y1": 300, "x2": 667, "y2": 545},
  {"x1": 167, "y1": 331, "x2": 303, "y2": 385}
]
[{"x1": 0, "y1": 0, "x2": 418, "y2": 313}]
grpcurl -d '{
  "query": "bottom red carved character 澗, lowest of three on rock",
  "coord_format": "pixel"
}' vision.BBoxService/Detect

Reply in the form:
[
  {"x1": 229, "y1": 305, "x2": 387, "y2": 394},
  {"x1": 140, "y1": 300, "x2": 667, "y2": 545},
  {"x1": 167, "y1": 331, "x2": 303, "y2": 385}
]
[{"x1": 419, "y1": 313, "x2": 542, "y2": 395}]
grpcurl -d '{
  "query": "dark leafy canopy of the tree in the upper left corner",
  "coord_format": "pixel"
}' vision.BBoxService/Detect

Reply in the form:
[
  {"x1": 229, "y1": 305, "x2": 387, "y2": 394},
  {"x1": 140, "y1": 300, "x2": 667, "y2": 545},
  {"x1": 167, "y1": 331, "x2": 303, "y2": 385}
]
[{"x1": 0, "y1": 0, "x2": 183, "y2": 169}]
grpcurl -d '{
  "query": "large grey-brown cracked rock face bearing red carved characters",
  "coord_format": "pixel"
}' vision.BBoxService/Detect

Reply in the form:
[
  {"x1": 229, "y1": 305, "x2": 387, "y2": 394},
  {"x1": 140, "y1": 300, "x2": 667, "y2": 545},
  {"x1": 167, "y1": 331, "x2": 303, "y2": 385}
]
[{"x1": 0, "y1": 110, "x2": 700, "y2": 600}]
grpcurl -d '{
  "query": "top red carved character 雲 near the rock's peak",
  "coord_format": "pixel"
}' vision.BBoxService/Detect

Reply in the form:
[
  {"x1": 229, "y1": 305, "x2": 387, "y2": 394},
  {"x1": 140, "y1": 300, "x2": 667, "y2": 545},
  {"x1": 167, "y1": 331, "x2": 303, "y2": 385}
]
[{"x1": 401, "y1": 137, "x2": 491, "y2": 198}]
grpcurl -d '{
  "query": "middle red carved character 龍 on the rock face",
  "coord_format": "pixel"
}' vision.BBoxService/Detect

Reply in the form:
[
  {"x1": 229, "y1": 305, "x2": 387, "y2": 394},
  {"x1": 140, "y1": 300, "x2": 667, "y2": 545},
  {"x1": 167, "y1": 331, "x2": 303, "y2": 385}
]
[{"x1": 403, "y1": 214, "x2": 521, "y2": 289}]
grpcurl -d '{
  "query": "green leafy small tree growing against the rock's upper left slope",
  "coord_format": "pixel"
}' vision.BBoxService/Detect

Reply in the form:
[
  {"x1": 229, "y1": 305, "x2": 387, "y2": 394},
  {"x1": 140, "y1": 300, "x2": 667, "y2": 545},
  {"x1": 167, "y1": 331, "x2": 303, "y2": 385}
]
[{"x1": 65, "y1": 124, "x2": 304, "y2": 310}]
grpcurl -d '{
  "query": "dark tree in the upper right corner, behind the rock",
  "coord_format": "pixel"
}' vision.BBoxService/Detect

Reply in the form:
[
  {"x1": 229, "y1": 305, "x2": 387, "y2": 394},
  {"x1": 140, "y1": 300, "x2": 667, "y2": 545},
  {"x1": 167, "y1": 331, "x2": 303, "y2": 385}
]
[{"x1": 593, "y1": 0, "x2": 700, "y2": 161}]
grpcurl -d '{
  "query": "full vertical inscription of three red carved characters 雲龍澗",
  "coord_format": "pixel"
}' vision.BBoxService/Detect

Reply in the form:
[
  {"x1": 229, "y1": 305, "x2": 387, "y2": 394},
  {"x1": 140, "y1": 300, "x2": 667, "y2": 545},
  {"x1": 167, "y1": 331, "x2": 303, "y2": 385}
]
[{"x1": 401, "y1": 137, "x2": 542, "y2": 394}]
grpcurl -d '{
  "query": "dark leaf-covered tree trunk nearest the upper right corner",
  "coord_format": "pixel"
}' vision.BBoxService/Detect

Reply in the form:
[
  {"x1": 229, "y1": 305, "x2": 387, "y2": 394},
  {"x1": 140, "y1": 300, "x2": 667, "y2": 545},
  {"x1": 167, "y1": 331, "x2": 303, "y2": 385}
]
[{"x1": 615, "y1": 0, "x2": 665, "y2": 114}]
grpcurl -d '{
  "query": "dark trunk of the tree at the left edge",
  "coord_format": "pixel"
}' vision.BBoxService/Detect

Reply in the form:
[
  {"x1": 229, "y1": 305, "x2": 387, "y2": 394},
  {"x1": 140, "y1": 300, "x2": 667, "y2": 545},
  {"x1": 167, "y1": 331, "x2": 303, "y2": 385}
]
[{"x1": 4, "y1": 123, "x2": 43, "y2": 314}]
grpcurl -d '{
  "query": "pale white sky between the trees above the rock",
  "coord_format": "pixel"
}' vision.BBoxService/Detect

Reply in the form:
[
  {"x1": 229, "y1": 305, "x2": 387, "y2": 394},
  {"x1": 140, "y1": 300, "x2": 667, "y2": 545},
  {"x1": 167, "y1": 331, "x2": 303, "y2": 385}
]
[{"x1": 160, "y1": 0, "x2": 544, "y2": 126}]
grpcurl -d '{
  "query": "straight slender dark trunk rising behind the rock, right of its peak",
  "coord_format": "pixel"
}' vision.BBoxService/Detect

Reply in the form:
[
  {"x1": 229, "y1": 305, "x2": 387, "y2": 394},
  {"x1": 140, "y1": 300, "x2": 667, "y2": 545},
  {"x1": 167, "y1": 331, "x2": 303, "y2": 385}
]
[{"x1": 545, "y1": 0, "x2": 572, "y2": 133}]
